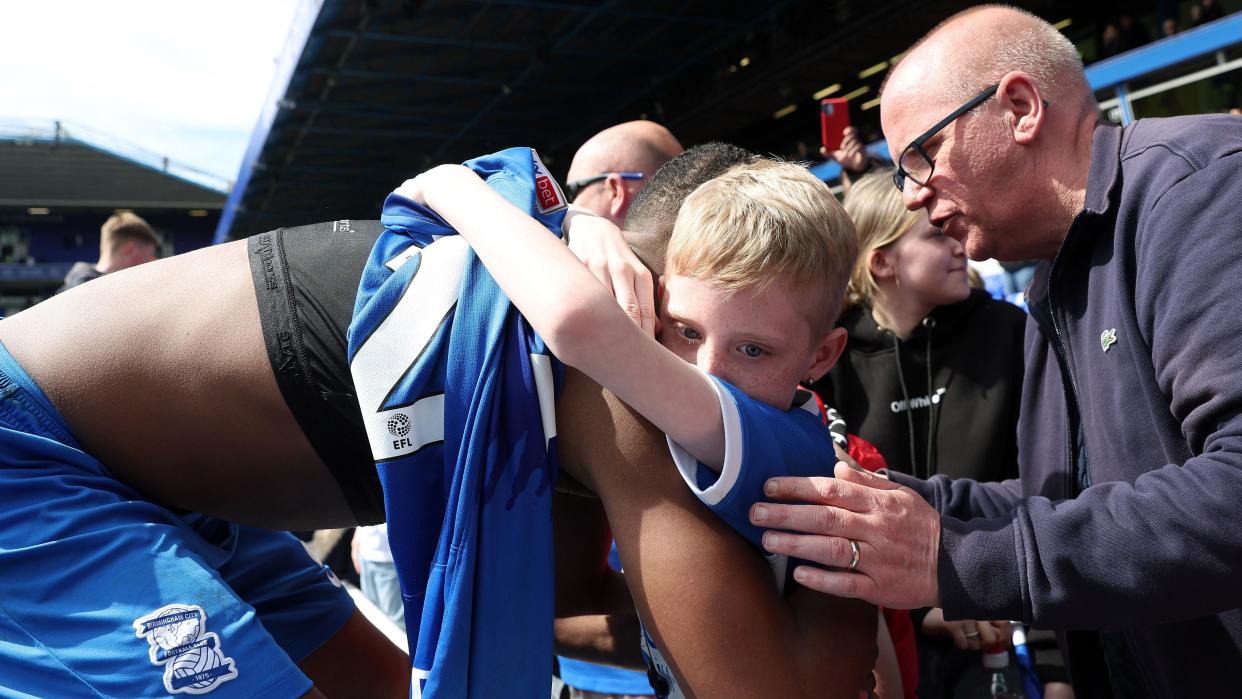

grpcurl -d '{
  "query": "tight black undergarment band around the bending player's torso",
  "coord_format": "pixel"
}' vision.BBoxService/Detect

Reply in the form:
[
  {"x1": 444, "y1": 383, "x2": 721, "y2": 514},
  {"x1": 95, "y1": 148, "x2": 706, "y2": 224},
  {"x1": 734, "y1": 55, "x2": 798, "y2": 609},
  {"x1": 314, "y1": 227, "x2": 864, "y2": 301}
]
[{"x1": 247, "y1": 220, "x2": 384, "y2": 524}]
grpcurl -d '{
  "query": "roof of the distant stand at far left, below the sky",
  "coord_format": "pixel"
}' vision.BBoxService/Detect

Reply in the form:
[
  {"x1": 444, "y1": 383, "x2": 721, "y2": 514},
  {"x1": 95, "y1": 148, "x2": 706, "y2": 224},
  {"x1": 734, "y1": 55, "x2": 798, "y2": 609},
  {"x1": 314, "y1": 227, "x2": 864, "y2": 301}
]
[{"x1": 0, "y1": 122, "x2": 229, "y2": 211}]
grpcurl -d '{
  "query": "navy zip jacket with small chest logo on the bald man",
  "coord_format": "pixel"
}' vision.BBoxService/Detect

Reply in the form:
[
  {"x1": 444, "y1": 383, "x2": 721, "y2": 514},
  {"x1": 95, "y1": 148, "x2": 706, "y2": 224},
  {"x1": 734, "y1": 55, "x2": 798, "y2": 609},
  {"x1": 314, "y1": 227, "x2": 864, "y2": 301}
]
[{"x1": 893, "y1": 115, "x2": 1242, "y2": 697}]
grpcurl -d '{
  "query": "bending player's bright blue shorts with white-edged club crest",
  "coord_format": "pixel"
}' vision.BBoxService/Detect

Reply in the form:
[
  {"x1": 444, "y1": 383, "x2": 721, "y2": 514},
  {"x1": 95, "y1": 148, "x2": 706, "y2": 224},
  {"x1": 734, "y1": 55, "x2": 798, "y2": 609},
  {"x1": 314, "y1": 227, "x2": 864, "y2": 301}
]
[{"x1": 0, "y1": 344, "x2": 354, "y2": 698}]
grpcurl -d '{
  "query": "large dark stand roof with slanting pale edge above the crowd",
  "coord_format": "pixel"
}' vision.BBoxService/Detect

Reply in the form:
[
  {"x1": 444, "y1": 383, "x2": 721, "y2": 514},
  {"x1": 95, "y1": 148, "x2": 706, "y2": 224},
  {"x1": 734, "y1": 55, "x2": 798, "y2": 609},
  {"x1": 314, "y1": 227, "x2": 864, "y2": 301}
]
[{"x1": 216, "y1": 0, "x2": 1107, "y2": 241}]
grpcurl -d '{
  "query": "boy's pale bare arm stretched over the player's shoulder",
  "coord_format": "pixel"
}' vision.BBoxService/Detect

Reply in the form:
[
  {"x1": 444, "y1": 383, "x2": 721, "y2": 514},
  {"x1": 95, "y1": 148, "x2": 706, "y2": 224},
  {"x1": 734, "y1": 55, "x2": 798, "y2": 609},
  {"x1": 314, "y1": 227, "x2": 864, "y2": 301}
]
[{"x1": 414, "y1": 165, "x2": 724, "y2": 468}]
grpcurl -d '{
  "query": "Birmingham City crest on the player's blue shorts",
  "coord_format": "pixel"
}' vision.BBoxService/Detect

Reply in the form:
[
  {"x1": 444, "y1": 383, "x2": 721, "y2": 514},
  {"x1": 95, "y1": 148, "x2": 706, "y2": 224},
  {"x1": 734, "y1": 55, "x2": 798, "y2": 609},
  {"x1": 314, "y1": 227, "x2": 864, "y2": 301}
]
[{"x1": 134, "y1": 605, "x2": 237, "y2": 694}]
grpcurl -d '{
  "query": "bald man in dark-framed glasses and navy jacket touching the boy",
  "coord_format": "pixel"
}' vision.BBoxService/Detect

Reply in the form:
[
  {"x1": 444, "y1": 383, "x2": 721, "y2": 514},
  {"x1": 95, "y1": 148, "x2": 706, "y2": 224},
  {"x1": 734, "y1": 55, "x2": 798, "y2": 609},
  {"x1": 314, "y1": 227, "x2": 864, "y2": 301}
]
[{"x1": 751, "y1": 5, "x2": 1242, "y2": 698}]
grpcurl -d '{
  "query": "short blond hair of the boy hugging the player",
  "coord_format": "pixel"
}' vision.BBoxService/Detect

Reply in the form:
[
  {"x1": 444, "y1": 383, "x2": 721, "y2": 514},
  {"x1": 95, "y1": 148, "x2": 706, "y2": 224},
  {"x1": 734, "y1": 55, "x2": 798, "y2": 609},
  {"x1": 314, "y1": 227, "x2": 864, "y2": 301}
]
[{"x1": 666, "y1": 159, "x2": 858, "y2": 333}]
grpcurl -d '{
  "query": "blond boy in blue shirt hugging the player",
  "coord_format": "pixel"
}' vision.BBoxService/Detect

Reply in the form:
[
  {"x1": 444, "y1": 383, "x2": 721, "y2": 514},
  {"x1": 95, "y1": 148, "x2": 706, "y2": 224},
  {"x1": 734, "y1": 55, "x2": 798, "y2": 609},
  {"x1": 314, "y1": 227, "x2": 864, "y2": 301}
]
[{"x1": 407, "y1": 161, "x2": 857, "y2": 695}]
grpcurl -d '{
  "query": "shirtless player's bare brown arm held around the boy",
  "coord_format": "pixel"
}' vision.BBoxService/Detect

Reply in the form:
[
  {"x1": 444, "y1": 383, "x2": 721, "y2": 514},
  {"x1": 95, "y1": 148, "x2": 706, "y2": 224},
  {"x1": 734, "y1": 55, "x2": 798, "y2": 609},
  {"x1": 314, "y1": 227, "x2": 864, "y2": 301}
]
[{"x1": 556, "y1": 371, "x2": 876, "y2": 698}]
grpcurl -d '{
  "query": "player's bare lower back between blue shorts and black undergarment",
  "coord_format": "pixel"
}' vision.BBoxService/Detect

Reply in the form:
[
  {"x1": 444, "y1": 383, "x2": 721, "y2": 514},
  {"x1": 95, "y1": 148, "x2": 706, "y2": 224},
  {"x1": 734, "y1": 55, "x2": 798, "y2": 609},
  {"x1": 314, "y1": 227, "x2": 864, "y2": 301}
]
[{"x1": 0, "y1": 241, "x2": 353, "y2": 529}]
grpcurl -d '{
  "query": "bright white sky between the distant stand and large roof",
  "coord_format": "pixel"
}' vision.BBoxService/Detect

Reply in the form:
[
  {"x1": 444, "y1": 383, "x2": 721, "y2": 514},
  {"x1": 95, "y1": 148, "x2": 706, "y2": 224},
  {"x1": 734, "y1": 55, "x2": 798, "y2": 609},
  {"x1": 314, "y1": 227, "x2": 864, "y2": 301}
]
[{"x1": 0, "y1": 0, "x2": 306, "y2": 187}]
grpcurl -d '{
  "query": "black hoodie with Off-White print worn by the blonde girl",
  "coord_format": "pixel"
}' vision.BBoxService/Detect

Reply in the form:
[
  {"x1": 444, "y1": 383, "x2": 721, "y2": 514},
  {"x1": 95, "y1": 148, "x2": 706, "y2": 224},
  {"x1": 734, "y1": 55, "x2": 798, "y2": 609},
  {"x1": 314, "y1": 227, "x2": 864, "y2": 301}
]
[{"x1": 811, "y1": 289, "x2": 1026, "y2": 480}]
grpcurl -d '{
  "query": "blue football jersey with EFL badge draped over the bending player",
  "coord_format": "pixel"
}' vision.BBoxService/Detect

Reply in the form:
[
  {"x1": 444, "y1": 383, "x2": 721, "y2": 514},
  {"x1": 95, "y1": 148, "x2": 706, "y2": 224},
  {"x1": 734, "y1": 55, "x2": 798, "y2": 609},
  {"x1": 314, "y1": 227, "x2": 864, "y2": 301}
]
[{"x1": 349, "y1": 148, "x2": 565, "y2": 698}]
